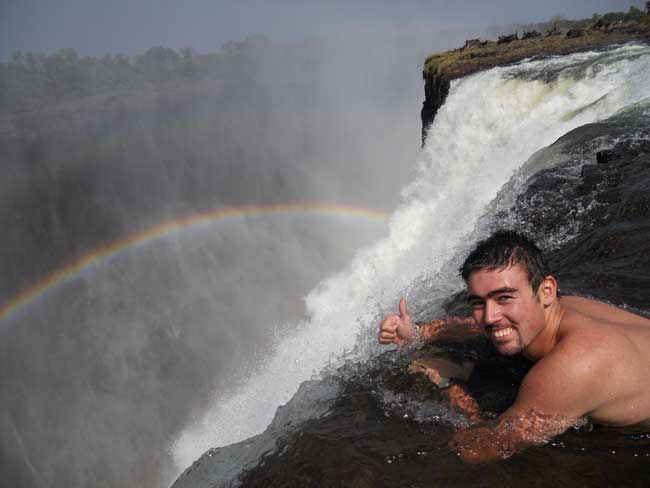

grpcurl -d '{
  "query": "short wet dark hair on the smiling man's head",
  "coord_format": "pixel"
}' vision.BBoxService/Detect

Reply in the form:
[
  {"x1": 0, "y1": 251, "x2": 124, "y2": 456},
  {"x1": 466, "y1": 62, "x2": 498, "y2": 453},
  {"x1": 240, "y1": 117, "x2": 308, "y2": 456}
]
[{"x1": 458, "y1": 230, "x2": 550, "y2": 293}]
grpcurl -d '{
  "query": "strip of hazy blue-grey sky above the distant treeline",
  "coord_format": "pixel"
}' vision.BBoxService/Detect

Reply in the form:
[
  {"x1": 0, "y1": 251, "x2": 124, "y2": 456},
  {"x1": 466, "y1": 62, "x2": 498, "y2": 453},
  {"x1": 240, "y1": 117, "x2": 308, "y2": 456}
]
[{"x1": 0, "y1": 0, "x2": 644, "y2": 59}]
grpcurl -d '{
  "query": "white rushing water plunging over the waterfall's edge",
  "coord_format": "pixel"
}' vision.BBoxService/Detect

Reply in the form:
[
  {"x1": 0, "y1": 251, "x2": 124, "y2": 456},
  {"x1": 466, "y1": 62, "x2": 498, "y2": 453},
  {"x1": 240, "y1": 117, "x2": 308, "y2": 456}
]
[{"x1": 172, "y1": 45, "x2": 650, "y2": 472}]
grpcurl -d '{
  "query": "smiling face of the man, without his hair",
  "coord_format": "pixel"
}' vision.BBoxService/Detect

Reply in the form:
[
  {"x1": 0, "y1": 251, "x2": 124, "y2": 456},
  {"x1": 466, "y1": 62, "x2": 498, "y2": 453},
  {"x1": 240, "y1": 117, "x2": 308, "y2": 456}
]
[{"x1": 467, "y1": 264, "x2": 545, "y2": 356}]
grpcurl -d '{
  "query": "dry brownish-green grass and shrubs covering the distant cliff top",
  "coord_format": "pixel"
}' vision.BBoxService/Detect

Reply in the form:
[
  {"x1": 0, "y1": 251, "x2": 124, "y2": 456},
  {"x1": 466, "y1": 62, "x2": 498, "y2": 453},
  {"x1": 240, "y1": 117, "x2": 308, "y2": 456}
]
[{"x1": 424, "y1": 2, "x2": 650, "y2": 80}]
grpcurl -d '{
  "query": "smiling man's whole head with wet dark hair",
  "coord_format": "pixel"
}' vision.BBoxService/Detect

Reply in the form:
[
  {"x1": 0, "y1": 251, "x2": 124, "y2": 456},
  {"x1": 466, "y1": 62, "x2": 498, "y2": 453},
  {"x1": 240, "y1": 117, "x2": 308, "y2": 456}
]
[{"x1": 460, "y1": 231, "x2": 557, "y2": 357}]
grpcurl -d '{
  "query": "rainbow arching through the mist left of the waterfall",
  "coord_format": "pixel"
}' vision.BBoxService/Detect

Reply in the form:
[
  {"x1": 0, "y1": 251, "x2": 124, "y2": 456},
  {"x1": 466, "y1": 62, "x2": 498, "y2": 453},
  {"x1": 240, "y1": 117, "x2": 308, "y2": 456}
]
[{"x1": 0, "y1": 203, "x2": 388, "y2": 320}]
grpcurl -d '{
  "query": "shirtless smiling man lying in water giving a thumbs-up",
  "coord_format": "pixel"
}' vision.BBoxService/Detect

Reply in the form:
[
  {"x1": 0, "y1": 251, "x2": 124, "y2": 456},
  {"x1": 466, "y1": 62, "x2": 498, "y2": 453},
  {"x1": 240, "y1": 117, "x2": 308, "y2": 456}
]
[{"x1": 379, "y1": 231, "x2": 650, "y2": 463}]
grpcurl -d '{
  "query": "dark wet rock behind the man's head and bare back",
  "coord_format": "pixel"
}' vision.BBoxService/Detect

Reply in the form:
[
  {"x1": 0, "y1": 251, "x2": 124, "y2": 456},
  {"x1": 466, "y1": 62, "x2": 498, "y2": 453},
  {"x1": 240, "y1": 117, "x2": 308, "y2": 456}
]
[{"x1": 488, "y1": 118, "x2": 650, "y2": 311}]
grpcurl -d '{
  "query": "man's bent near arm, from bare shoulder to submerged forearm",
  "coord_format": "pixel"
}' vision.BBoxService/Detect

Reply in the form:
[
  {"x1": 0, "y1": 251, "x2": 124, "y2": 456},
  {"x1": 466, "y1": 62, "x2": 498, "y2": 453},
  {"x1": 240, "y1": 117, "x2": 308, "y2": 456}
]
[{"x1": 449, "y1": 342, "x2": 602, "y2": 463}]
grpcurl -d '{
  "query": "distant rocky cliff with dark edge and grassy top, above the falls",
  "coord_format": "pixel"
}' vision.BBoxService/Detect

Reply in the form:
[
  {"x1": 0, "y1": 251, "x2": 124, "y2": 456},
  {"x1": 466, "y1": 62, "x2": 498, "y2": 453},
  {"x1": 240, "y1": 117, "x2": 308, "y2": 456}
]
[{"x1": 421, "y1": 14, "x2": 650, "y2": 144}]
